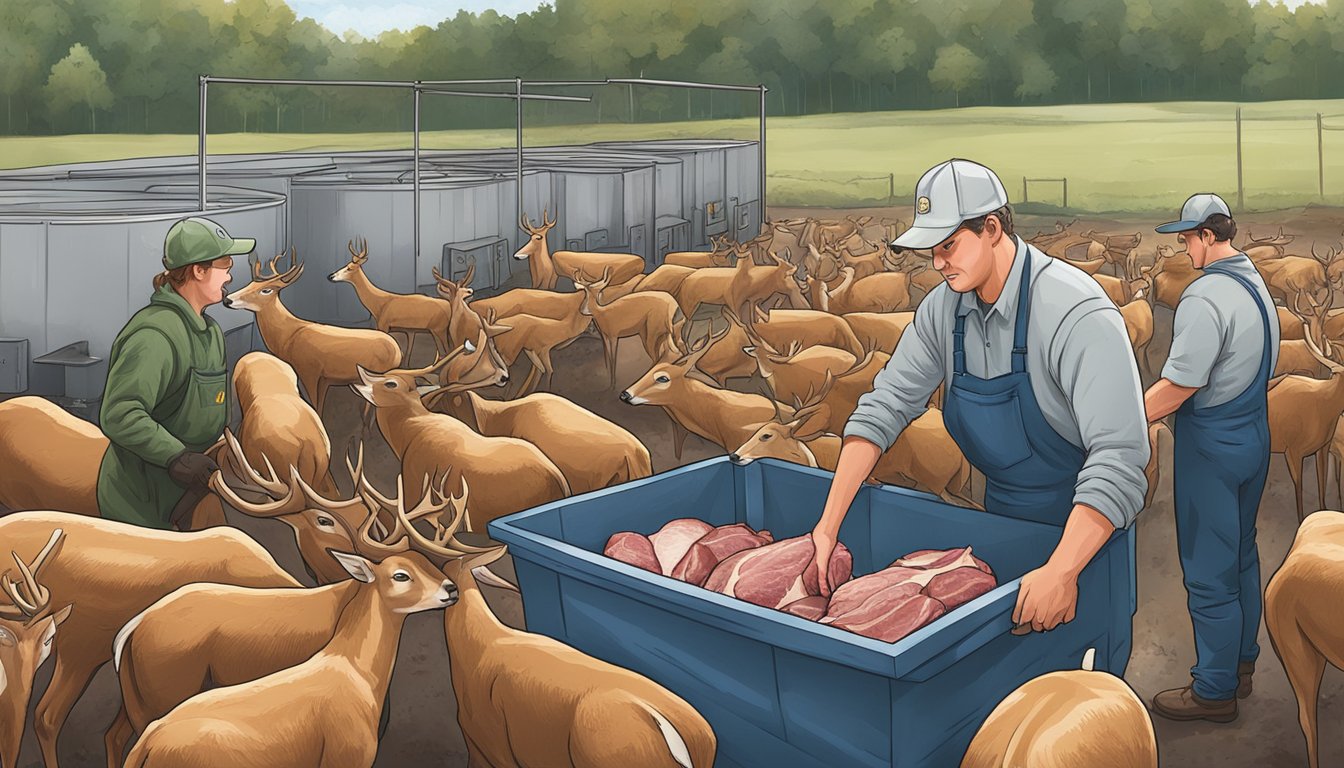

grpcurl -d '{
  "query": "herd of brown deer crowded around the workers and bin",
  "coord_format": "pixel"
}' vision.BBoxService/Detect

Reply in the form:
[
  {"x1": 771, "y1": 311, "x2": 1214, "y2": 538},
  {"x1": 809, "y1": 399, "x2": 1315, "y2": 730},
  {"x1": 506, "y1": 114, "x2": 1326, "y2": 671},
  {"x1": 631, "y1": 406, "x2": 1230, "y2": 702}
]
[{"x1": 0, "y1": 207, "x2": 1344, "y2": 768}]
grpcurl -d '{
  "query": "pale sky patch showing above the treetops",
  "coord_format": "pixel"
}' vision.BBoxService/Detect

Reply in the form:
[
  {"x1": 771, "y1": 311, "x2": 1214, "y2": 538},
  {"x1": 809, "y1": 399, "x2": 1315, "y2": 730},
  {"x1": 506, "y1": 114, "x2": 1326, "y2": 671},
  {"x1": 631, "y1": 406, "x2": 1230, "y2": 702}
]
[{"x1": 288, "y1": 0, "x2": 1324, "y2": 38}]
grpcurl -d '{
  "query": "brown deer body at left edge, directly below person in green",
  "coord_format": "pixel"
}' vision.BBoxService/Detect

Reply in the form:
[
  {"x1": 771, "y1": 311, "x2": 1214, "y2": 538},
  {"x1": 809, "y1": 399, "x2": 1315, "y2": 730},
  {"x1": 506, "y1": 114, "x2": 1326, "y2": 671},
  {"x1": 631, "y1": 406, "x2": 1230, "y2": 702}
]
[{"x1": 0, "y1": 511, "x2": 301, "y2": 768}]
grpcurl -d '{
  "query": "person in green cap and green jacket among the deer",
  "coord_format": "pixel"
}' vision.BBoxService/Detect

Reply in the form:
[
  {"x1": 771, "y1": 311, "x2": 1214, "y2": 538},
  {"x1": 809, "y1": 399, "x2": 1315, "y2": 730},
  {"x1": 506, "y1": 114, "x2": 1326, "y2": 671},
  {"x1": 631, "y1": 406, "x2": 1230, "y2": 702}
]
[{"x1": 98, "y1": 217, "x2": 257, "y2": 529}]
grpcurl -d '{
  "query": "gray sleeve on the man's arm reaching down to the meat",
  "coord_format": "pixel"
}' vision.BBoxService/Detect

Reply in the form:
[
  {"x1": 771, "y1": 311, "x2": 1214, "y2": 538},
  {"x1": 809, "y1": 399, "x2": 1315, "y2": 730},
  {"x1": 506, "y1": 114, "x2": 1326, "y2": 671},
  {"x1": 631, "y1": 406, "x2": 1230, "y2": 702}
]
[{"x1": 843, "y1": 299, "x2": 946, "y2": 451}]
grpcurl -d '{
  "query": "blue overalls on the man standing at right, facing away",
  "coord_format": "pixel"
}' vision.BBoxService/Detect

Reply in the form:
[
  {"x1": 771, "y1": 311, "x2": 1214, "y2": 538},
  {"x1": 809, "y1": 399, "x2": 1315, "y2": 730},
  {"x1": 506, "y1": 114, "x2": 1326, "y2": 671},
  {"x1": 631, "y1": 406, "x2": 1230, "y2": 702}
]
[{"x1": 1172, "y1": 261, "x2": 1278, "y2": 701}]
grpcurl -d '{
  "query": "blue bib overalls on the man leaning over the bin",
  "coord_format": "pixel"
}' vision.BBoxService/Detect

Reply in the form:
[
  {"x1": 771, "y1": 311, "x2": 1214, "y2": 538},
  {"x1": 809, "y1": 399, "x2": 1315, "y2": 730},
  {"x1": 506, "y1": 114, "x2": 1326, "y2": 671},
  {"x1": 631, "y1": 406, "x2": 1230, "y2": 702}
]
[{"x1": 942, "y1": 247, "x2": 1086, "y2": 526}]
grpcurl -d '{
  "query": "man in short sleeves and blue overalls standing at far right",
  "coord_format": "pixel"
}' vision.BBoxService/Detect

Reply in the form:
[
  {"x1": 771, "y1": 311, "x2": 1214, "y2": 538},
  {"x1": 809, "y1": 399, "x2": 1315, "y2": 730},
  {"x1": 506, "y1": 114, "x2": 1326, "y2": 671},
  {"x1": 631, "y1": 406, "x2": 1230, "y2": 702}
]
[{"x1": 1144, "y1": 194, "x2": 1279, "y2": 722}]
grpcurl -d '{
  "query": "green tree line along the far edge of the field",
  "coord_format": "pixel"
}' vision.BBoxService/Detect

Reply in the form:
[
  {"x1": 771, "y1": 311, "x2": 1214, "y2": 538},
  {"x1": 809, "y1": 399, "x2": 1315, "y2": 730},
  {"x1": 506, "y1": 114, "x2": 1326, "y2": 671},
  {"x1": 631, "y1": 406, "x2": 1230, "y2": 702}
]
[{"x1": 0, "y1": 0, "x2": 1344, "y2": 135}]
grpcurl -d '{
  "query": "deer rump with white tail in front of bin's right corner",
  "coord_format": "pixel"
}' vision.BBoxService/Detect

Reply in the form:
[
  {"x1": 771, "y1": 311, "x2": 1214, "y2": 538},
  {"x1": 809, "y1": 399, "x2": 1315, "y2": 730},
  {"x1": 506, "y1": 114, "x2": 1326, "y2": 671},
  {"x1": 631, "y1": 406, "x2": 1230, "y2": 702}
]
[{"x1": 961, "y1": 648, "x2": 1157, "y2": 768}]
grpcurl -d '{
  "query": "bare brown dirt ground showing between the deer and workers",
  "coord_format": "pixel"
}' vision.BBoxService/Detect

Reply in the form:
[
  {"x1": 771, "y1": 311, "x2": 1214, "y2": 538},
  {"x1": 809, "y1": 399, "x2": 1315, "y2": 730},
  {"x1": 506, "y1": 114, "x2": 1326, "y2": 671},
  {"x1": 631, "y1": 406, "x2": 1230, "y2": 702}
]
[{"x1": 19, "y1": 207, "x2": 1344, "y2": 768}]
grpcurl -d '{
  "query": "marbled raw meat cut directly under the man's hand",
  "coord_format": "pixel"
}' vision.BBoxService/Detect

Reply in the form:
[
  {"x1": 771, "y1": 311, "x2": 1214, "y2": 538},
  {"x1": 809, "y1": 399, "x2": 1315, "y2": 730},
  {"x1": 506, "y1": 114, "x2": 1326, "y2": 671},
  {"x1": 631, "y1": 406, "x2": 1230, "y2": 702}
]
[{"x1": 704, "y1": 535, "x2": 853, "y2": 608}]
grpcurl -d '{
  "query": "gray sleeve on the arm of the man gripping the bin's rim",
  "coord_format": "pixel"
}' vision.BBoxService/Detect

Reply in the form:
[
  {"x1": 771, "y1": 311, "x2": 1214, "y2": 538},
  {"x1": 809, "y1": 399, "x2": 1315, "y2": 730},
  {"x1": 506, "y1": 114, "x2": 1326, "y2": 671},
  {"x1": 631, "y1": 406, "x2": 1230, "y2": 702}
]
[{"x1": 1051, "y1": 303, "x2": 1149, "y2": 529}]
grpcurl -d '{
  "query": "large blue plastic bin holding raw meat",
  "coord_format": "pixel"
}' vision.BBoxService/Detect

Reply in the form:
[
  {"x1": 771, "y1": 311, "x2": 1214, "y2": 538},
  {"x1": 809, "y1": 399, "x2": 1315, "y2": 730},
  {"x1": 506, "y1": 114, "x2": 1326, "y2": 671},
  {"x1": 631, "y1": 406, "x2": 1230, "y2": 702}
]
[{"x1": 489, "y1": 456, "x2": 1136, "y2": 768}]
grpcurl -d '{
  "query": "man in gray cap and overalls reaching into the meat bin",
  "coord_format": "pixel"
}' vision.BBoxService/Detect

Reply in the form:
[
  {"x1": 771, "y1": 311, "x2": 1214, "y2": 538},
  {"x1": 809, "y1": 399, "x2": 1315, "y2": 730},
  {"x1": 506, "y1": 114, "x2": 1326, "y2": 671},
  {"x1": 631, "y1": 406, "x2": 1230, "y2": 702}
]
[{"x1": 812, "y1": 160, "x2": 1149, "y2": 650}]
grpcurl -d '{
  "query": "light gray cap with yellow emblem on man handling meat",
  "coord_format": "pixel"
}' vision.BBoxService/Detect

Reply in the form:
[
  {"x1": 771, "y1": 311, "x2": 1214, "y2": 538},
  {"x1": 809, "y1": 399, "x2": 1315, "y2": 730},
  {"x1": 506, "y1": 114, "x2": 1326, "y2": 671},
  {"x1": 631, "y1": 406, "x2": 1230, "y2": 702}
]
[{"x1": 891, "y1": 159, "x2": 1008, "y2": 249}]
